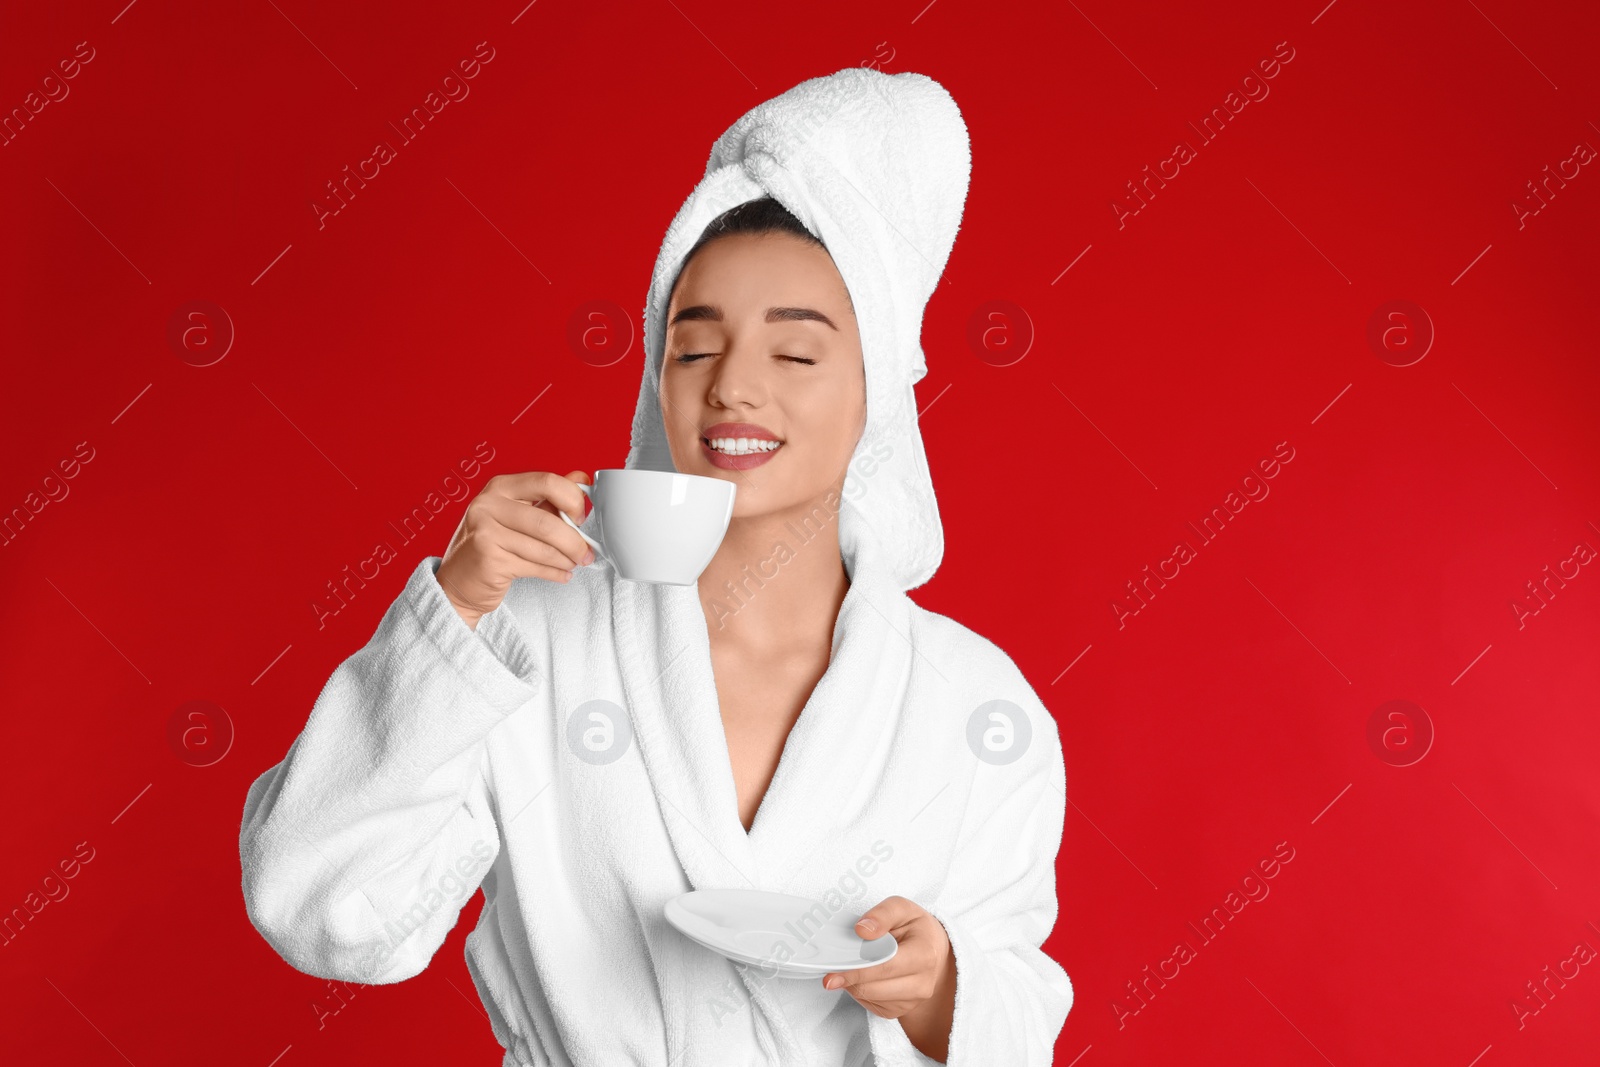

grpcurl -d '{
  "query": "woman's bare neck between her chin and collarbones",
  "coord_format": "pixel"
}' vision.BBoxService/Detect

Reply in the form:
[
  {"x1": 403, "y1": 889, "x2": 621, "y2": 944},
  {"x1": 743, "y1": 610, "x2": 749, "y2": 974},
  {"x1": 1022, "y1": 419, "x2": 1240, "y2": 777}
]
[{"x1": 699, "y1": 493, "x2": 850, "y2": 653}]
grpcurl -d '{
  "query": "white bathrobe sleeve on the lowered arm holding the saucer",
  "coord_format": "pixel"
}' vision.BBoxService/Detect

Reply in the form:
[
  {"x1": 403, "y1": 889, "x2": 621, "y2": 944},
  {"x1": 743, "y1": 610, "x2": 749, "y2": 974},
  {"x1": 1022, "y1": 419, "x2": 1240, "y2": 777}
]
[{"x1": 867, "y1": 653, "x2": 1072, "y2": 1067}]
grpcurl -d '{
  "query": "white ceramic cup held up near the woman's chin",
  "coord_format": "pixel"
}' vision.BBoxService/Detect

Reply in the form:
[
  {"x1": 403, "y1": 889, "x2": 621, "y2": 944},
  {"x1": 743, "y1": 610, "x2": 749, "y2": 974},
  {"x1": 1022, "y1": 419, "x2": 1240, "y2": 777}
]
[{"x1": 558, "y1": 469, "x2": 739, "y2": 585}]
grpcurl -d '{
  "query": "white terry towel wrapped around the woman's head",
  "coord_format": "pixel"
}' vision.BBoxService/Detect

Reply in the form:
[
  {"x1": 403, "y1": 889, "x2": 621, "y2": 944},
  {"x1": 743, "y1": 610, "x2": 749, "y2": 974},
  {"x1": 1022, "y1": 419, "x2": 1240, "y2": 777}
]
[{"x1": 626, "y1": 67, "x2": 971, "y2": 590}]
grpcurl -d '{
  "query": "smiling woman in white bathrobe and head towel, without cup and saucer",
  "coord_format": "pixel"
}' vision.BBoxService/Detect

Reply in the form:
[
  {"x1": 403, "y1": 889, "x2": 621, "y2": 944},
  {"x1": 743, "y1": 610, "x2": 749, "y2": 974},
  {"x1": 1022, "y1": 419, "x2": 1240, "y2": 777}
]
[{"x1": 240, "y1": 69, "x2": 1072, "y2": 1067}]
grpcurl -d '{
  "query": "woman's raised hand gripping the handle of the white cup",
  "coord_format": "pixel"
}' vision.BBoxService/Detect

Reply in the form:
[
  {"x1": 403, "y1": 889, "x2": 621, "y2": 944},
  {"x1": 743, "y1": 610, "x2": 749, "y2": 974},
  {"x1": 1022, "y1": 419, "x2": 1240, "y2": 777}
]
[{"x1": 435, "y1": 470, "x2": 595, "y2": 630}]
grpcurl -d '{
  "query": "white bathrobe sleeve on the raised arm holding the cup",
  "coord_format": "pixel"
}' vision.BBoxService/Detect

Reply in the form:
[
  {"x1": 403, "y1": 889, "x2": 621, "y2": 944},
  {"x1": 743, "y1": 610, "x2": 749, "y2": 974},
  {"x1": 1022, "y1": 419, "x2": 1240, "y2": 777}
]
[{"x1": 238, "y1": 557, "x2": 539, "y2": 984}]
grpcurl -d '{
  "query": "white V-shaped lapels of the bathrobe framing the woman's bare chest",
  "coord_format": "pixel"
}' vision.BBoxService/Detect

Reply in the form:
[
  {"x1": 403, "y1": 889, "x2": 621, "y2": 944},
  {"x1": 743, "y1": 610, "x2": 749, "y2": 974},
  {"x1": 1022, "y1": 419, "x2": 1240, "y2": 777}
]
[{"x1": 611, "y1": 571, "x2": 915, "y2": 893}]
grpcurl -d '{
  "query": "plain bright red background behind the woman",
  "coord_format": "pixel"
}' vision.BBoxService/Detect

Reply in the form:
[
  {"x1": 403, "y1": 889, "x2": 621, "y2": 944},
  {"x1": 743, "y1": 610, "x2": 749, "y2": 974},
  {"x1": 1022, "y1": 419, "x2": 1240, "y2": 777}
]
[{"x1": 0, "y1": 0, "x2": 1600, "y2": 1067}]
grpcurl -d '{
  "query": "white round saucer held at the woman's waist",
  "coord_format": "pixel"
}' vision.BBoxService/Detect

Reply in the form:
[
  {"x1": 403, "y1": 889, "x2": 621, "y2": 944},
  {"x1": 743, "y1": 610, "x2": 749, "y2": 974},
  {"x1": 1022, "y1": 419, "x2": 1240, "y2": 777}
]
[{"x1": 666, "y1": 889, "x2": 899, "y2": 977}]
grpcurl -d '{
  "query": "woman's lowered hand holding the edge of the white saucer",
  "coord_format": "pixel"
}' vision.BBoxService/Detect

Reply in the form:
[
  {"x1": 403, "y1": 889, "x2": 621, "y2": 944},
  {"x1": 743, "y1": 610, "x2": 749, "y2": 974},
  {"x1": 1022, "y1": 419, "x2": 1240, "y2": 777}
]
[{"x1": 822, "y1": 896, "x2": 955, "y2": 1061}]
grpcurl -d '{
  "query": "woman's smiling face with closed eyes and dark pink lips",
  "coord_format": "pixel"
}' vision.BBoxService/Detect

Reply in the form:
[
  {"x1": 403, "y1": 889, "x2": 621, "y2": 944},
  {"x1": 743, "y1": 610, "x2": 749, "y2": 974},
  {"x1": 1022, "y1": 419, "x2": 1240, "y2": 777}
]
[{"x1": 661, "y1": 234, "x2": 867, "y2": 518}]
